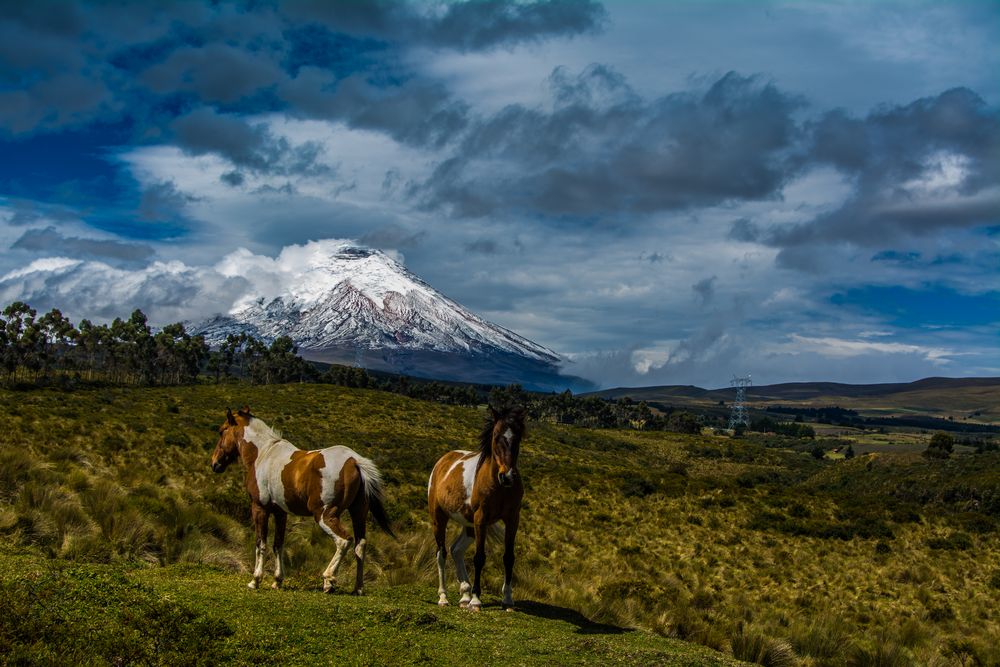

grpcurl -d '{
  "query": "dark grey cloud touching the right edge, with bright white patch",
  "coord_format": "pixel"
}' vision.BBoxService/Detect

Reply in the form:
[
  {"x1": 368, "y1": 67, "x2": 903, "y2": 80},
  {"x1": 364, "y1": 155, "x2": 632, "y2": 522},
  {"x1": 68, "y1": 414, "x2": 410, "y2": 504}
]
[{"x1": 768, "y1": 88, "x2": 1000, "y2": 268}]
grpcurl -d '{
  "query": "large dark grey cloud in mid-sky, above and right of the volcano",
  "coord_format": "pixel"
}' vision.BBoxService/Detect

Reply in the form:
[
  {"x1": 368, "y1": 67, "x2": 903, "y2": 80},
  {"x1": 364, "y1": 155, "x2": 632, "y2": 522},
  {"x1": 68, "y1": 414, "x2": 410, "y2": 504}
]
[{"x1": 415, "y1": 70, "x2": 802, "y2": 219}]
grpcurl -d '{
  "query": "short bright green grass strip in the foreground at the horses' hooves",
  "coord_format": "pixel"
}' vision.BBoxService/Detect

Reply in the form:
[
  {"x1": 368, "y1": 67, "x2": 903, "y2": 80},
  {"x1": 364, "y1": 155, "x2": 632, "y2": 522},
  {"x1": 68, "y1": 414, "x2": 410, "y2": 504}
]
[{"x1": 0, "y1": 551, "x2": 731, "y2": 665}]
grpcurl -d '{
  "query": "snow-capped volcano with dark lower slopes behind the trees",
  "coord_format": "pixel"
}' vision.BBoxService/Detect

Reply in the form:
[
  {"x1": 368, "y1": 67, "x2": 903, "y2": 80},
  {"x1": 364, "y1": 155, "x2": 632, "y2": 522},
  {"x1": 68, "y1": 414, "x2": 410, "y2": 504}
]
[{"x1": 193, "y1": 240, "x2": 580, "y2": 382}]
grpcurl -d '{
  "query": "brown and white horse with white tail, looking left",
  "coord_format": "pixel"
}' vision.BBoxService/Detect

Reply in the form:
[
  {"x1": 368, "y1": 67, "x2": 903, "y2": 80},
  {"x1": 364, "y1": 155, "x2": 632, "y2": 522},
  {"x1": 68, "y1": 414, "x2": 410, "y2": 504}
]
[{"x1": 212, "y1": 406, "x2": 393, "y2": 595}]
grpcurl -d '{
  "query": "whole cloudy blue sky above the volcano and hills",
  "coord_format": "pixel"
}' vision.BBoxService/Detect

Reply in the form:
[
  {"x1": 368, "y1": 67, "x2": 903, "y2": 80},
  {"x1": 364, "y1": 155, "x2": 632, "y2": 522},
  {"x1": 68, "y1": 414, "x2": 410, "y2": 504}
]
[{"x1": 0, "y1": 0, "x2": 1000, "y2": 386}]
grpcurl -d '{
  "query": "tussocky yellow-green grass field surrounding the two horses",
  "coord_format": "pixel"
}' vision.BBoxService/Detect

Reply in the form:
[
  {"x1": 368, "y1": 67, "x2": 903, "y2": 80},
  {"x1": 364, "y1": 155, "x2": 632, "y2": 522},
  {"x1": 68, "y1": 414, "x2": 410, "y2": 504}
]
[{"x1": 0, "y1": 385, "x2": 1000, "y2": 665}]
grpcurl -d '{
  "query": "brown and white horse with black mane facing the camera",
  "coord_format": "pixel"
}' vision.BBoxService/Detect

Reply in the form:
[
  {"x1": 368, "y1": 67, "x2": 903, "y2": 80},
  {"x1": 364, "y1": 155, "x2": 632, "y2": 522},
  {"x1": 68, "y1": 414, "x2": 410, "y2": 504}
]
[{"x1": 427, "y1": 407, "x2": 524, "y2": 611}]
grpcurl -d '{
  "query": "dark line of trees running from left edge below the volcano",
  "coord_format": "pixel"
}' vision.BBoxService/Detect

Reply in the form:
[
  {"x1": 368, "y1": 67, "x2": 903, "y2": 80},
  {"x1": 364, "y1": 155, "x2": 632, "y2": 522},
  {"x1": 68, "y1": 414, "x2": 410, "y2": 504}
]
[{"x1": 0, "y1": 301, "x2": 740, "y2": 433}]
